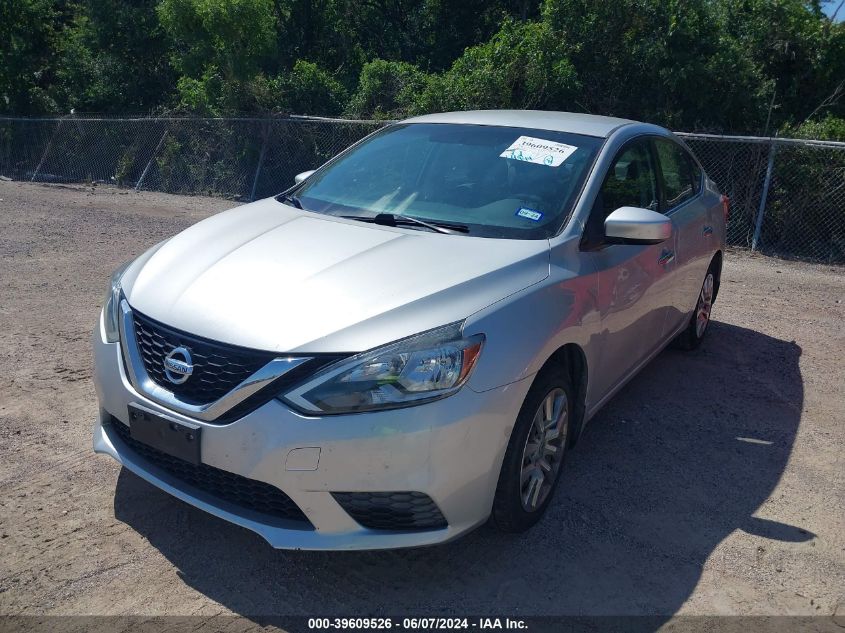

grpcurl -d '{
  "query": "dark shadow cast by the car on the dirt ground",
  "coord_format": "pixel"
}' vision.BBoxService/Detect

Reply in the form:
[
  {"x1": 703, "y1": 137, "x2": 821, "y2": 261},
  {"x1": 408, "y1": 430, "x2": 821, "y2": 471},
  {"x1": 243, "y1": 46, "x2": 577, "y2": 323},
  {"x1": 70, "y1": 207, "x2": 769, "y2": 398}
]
[{"x1": 114, "y1": 322, "x2": 812, "y2": 620}]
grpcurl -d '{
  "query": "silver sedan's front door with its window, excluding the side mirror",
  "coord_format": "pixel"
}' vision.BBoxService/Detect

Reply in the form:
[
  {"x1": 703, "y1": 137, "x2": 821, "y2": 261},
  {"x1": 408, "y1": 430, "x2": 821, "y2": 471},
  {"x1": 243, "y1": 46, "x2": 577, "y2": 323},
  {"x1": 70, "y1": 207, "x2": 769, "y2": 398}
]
[{"x1": 581, "y1": 137, "x2": 675, "y2": 397}]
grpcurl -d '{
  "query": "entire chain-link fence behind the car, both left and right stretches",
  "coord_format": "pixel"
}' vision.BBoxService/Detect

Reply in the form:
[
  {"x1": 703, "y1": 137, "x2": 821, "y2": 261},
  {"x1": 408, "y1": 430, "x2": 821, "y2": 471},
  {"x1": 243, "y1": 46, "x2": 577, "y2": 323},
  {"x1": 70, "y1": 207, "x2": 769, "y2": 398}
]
[{"x1": 0, "y1": 117, "x2": 845, "y2": 263}]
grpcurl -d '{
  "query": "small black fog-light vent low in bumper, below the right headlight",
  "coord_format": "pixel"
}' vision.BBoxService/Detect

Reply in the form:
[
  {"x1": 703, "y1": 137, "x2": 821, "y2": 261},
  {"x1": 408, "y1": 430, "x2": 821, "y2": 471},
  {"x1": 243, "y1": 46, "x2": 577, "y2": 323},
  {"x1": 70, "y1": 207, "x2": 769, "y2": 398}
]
[{"x1": 332, "y1": 492, "x2": 446, "y2": 530}]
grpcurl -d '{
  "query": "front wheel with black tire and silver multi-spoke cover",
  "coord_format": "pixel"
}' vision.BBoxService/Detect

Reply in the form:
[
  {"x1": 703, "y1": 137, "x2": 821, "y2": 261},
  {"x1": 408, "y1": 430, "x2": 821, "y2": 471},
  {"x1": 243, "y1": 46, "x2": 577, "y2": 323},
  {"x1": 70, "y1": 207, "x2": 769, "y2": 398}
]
[{"x1": 491, "y1": 367, "x2": 575, "y2": 533}]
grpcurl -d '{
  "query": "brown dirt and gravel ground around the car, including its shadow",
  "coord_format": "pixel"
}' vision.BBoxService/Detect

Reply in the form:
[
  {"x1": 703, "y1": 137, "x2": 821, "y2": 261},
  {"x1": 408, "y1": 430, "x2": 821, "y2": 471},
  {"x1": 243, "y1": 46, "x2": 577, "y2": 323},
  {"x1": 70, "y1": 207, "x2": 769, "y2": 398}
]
[{"x1": 0, "y1": 182, "x2": 845, "y2": 626}]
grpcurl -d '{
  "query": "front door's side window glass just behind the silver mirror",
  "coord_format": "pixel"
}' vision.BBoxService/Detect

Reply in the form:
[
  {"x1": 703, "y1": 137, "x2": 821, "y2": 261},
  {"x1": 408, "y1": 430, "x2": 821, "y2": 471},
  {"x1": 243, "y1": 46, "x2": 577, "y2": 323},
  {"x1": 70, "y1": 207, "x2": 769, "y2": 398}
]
[{"x1": 582, "y1": 139, "x2": 659, "y2": 249}]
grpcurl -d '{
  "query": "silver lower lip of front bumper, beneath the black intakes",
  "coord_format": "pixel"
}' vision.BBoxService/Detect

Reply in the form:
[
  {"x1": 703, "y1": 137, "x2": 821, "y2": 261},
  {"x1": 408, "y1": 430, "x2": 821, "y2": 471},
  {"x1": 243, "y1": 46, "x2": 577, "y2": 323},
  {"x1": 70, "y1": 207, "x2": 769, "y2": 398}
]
[{"x1": 94, "y1": 420, "x2": 483, "y2": 551}]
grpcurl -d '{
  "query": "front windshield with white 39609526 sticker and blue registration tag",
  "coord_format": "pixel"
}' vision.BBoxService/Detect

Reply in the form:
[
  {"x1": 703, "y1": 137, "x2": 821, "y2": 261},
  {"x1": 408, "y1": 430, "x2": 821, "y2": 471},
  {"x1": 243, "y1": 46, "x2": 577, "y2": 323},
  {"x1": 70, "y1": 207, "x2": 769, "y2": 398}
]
[{"x1": 290, "y1": 123, "x2": 603, "y2": 239}]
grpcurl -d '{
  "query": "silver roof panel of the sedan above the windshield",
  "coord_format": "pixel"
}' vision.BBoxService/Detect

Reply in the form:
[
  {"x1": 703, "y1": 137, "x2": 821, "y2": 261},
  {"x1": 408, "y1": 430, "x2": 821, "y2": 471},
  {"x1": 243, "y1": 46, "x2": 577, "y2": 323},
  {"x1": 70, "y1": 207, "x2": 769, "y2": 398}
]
[{"x1": 401, "y1": 110, "x2": 637, "y2": 138}]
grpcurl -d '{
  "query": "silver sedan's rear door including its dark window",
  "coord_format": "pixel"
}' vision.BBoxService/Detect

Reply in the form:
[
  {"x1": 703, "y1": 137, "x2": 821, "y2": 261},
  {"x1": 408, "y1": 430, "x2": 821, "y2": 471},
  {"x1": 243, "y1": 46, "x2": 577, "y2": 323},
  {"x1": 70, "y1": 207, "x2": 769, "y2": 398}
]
[{"x1": 654, "y1": 137, "x2": 717, "y2": 336}]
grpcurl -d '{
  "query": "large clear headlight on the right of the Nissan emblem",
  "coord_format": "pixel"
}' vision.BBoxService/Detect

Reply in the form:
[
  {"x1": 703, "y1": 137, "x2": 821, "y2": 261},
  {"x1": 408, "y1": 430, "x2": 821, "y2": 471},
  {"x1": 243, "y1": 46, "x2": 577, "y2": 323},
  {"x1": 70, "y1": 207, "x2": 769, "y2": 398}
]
[{"x1": 282, "y1": 323, "x2": 484, "y2": 414}]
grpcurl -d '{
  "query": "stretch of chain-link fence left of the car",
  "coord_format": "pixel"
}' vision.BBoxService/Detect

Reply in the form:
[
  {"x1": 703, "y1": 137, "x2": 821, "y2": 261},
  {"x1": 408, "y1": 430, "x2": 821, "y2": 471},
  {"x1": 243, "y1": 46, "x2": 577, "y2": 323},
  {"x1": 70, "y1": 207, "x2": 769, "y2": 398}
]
[{"x1": 0, "y1": 117, "x2": 384, "y2": 200}]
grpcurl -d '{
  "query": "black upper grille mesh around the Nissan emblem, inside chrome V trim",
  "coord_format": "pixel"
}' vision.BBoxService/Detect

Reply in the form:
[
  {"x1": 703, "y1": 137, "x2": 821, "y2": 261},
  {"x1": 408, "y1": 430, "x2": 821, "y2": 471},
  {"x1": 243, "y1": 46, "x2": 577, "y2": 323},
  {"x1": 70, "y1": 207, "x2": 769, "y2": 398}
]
[{"x1": 132, "y1": 312, "x2": 276, "y2": 404}]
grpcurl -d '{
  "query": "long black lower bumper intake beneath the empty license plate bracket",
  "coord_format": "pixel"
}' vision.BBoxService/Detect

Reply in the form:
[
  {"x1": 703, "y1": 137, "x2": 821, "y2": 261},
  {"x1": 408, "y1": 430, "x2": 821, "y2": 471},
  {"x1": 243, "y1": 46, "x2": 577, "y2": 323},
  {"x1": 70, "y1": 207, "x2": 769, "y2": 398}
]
[{"x1": 111, "y1": 417, "x2": 310, "y2": 525}]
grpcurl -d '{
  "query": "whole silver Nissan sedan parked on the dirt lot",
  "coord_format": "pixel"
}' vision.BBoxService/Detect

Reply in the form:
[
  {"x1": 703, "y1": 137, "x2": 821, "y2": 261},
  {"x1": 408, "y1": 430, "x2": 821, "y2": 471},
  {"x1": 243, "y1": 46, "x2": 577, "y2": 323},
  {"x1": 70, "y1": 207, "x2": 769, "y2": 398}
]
[{"x1": 94, "y1": 111, "x2": 728, "y2": 549}]
